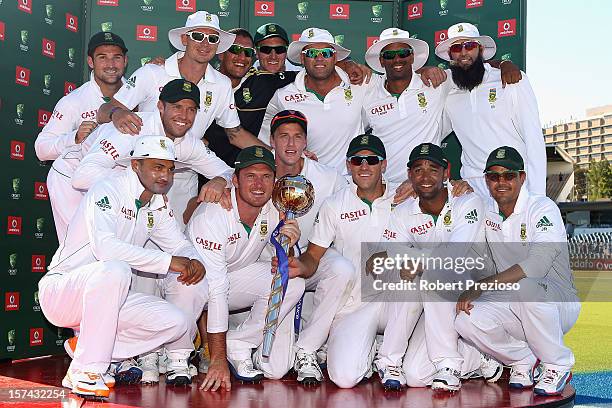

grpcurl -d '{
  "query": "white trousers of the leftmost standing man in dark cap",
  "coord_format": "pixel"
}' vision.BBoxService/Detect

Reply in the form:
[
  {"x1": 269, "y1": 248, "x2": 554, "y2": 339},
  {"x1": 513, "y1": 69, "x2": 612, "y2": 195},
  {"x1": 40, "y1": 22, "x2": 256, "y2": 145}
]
[{"x1": 47, "y1": 167, "x2": 84, "y2": 243}]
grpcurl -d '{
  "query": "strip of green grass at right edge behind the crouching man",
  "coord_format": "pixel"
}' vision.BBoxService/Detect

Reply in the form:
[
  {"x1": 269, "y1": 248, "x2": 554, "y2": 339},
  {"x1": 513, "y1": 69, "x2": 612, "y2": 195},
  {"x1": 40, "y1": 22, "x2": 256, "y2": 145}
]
[{"x1": 565, "y1": 271, "x2": 612, "y2": 372}]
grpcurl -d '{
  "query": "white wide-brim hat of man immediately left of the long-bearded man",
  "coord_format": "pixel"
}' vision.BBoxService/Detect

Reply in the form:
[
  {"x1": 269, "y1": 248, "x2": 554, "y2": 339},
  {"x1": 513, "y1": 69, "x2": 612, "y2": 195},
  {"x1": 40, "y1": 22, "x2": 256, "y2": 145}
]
[{"x1": 365, "y1": 27, "x2": 429, "y2": 74}]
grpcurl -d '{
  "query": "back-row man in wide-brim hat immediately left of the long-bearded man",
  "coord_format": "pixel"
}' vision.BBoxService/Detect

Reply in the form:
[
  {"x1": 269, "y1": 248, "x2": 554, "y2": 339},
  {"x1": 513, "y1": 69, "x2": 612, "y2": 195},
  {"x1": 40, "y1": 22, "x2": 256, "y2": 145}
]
[{"x1": 363, "y1": 28, "x2": 451, "y2": 183}]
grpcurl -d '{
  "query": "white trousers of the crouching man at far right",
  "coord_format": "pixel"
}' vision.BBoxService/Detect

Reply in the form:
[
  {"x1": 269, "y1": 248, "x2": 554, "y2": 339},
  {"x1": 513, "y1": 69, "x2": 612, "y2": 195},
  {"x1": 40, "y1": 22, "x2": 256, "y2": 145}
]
[{"x1": 455, "y1": 278, "x2": 580, "y2": 370}]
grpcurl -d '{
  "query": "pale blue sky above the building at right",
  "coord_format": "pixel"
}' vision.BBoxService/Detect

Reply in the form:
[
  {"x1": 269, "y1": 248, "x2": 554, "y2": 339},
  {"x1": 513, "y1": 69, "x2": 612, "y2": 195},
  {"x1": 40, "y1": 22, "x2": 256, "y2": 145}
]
[{"x1": 526, "y1": 0, "x2": 612, "y2": 125}]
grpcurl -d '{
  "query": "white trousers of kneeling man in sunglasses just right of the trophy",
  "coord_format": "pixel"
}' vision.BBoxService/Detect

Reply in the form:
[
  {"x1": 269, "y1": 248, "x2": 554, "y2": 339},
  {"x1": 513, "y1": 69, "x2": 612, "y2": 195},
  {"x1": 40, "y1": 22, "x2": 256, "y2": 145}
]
[{"x1": 327, "y1": 301, "x2": 423, "y2": 388}]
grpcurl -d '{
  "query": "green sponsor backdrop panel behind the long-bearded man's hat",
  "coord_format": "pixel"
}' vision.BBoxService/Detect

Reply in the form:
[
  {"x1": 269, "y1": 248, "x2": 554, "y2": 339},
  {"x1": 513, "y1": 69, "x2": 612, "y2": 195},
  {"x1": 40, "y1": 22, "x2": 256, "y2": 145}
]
[{"x1": 399, "y1": 0, "x2": 527, "y2": 179}]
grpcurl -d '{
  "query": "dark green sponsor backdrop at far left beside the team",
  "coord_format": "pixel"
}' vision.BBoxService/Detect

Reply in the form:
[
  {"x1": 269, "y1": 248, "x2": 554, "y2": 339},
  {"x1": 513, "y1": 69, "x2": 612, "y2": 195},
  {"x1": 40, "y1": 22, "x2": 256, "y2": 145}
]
[{"x1": 0, "y1": 0, "x2": 84, "y2": 359}]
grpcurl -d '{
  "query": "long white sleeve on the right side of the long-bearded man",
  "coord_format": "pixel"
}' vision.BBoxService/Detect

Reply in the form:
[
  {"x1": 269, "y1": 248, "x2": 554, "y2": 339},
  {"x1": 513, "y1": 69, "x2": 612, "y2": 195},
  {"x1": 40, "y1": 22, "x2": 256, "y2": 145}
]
[{"x1": 508, "y1": 73, "x2": 546, "y2": 195}]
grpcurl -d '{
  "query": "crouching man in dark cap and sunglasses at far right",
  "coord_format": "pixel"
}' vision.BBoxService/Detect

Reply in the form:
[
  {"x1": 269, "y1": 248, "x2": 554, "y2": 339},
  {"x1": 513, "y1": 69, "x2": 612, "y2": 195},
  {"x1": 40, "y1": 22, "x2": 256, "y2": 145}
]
[{"x1": 455, "y1": 146, "x2": 580, "y2": 395}]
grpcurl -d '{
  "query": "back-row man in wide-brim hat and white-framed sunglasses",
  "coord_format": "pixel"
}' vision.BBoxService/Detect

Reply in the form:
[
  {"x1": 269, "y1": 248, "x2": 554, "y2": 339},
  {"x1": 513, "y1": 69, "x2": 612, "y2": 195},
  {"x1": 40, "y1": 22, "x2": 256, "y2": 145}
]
[{"x1": 98, "y1": 11, "x2": 259, "y2": 225}]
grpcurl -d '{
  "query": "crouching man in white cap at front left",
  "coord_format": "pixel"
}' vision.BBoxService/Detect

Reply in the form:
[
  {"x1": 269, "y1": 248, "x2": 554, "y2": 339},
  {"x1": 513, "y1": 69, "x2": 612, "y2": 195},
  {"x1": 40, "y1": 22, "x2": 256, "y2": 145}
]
[{"x1": 38, "y1": 136, "x2": 205, "y2": 397}]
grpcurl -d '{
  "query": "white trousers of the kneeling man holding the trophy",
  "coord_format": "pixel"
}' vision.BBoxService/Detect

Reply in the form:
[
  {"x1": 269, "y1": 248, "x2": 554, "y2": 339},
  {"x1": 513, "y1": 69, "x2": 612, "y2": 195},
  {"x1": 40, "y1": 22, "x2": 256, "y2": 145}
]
[{"x1": 220, "y1": 262, "x2": 304, "y2": 378}]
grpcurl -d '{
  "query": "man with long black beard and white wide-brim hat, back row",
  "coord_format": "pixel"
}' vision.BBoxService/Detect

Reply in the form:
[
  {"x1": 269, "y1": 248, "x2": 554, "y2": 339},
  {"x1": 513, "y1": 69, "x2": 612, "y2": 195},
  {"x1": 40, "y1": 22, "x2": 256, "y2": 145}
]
[{"x1": 436, "y1": 23, "x2": 546, "y2": 197}]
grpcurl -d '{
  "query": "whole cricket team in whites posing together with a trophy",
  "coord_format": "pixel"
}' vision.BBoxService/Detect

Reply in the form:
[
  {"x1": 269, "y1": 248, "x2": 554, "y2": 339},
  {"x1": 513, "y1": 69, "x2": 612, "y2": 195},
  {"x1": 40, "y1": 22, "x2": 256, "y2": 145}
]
[{"x1": 35, "y1": 11, "x2": 580, "y2": 397}]
